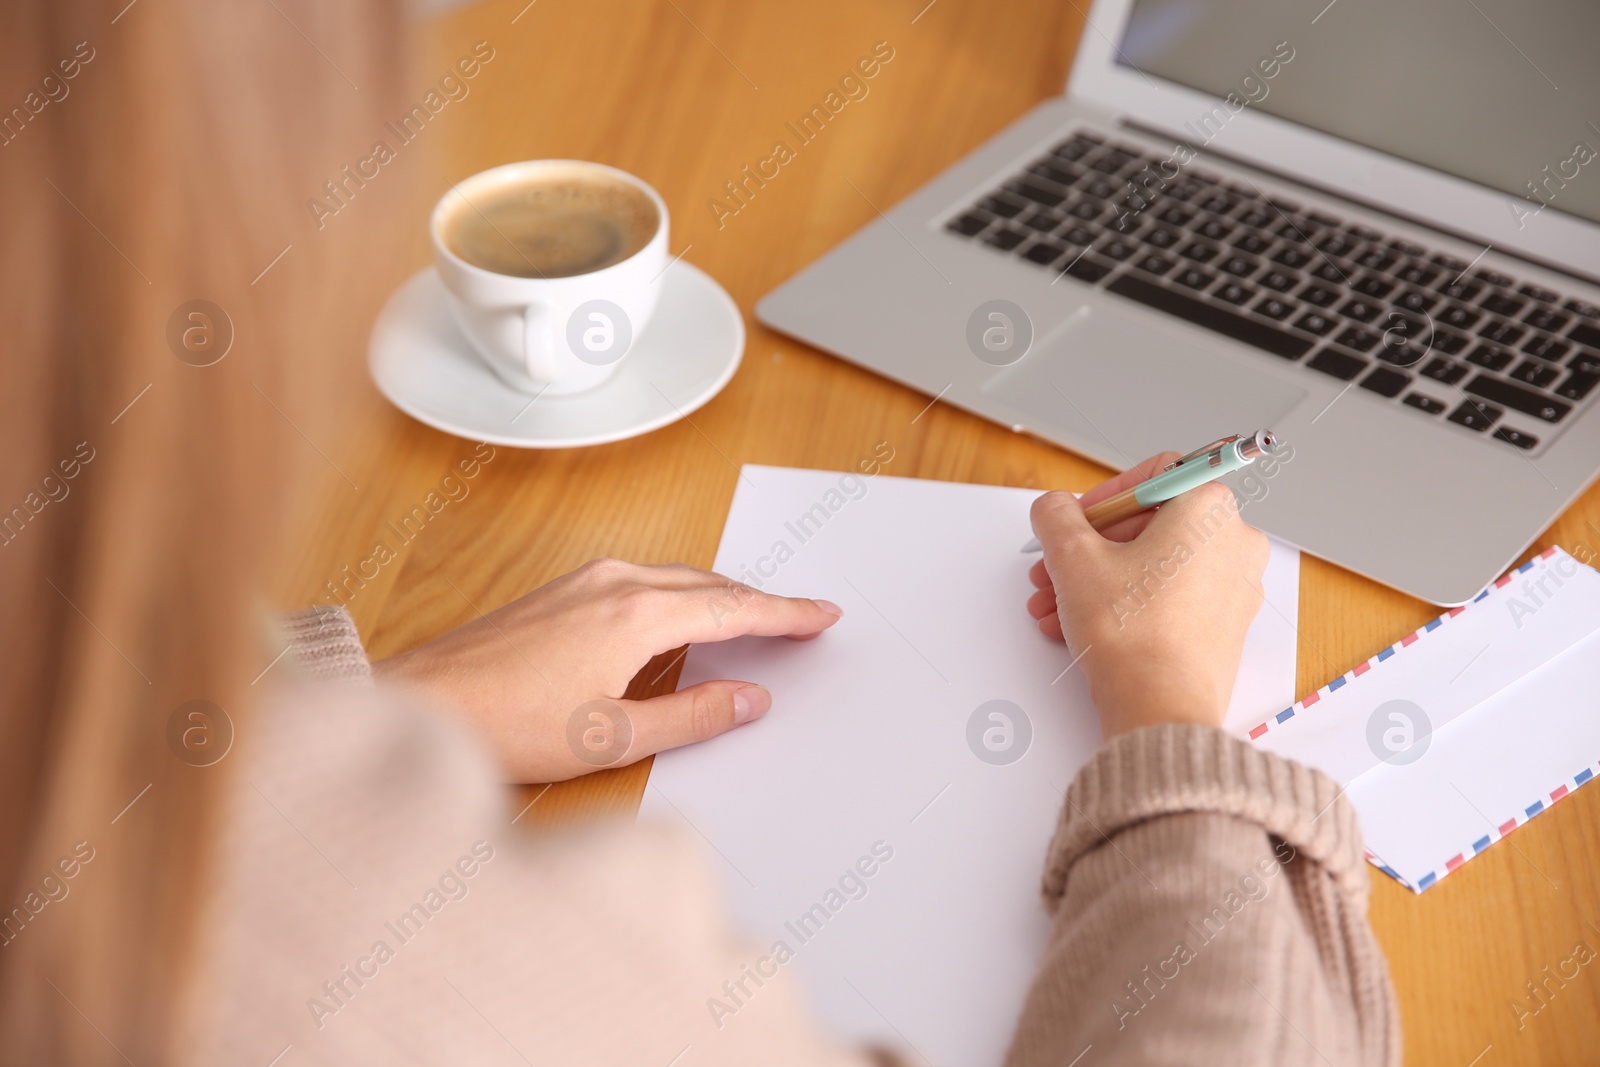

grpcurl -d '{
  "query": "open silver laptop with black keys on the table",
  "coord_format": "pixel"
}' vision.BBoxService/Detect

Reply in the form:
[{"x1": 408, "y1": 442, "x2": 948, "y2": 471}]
[{"x1": 757, "y1": 0, "x2": 1600, "y2": 605}]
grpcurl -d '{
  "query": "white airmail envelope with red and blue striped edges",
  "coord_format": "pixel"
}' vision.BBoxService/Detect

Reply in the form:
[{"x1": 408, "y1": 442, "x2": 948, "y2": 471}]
[{"x1": 1250, "y1": 547, "x2": 1600, "y2": 893}]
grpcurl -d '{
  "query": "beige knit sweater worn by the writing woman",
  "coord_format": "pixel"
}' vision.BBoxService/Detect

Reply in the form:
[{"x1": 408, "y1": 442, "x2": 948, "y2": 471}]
[{"x1": 186, "y1": 609, "x2": 1400, "y2": 1067}]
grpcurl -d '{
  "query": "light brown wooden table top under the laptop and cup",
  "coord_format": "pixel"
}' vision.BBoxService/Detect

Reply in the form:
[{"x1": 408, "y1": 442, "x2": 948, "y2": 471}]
[{"x1": 286, "y1": 0, "x2": 1600, "y2": 1067}]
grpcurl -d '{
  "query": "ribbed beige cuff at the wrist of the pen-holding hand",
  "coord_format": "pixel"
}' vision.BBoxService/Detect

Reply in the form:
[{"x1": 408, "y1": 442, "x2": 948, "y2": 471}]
[{"x1": 1043, "y1": 725, "x2": 1370, "y2": 910}]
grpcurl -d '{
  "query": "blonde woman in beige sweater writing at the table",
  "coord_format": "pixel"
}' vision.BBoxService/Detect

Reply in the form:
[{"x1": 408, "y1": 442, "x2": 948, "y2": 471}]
[{"x1": 0, "y1": 0, "x2": 1398, "y2": 1067}]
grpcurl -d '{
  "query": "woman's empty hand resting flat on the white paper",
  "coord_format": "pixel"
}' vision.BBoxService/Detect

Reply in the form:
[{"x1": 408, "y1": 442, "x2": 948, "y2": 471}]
[{"x1": 373, "y1": 560, "x2": 840, "y2": 782}]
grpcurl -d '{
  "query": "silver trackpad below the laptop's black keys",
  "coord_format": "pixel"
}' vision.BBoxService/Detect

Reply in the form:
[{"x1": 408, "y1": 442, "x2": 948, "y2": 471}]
[{"x1": 984, "y1": 307, "x2": 1306, "y2": 466}]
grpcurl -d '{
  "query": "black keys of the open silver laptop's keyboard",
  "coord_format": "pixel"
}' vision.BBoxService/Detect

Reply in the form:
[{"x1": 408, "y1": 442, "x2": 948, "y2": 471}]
[{"x1": 946, "y1": 133, "x2": 1600, "y2": 450}]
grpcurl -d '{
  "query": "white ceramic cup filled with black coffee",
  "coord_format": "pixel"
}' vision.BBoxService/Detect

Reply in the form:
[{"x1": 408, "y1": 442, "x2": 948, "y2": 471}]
[{"x1": 429, "y1": 160, "x2": 667, "y2": 397}]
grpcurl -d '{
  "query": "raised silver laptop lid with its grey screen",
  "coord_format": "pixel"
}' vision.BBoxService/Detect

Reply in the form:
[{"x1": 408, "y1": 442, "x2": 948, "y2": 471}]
[{"x1": 1067, "y1": 0, "x2": 1600, "y2": 282}]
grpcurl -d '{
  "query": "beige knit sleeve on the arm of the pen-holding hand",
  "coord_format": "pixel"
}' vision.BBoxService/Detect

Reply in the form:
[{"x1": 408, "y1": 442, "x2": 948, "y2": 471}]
[{"x1": 1006, "y1": 725, "x2": 1400, "y2": 1067}]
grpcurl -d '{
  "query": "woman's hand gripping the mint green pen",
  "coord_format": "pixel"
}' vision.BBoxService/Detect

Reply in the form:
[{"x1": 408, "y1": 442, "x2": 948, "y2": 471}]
[{"x1": 1027, "y1": 453, "x2": 1267, "y2": 741}]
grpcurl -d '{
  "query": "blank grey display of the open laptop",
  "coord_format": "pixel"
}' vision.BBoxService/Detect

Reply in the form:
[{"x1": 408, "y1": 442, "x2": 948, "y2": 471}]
[{"x1": 1117, "y1": 0, "x2": 1600, "y2": 222}]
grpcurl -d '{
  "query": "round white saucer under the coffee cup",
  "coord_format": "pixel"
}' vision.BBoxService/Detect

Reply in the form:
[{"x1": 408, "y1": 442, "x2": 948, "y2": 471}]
[{"x1": 366, "y1": 268, "x2": 744, "y2": 448}]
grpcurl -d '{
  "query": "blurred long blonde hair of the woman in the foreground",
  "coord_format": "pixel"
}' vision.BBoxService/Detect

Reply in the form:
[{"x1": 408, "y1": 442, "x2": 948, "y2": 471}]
[{"x1": 0, "y1": 0, "x2": 421, "y2": 1067}]
